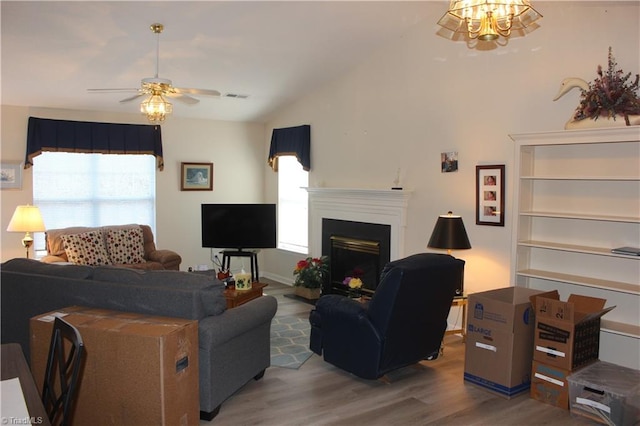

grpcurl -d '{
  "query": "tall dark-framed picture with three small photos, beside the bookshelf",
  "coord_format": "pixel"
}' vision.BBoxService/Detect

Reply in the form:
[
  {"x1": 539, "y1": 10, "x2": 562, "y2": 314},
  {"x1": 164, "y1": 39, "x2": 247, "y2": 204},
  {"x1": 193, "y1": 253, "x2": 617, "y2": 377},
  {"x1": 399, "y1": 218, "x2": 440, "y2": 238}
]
[{"x1": 476, "y1": 164, "x2": 504, "y2": 226}]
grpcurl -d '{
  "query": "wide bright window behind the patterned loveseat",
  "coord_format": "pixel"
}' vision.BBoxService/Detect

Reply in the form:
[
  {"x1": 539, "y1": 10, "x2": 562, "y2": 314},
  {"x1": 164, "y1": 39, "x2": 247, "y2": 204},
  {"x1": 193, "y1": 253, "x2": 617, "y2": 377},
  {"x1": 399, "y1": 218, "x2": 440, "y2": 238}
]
[{"x1": 33, "y1": 152, "x2": 156, "y2": 251}]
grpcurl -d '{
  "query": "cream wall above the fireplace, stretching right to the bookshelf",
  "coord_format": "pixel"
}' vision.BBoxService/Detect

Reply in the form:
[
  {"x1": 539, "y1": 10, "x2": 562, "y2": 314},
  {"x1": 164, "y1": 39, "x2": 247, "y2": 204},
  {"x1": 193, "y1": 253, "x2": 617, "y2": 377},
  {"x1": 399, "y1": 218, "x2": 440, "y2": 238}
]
[{"x1": 263, "y1": 1, "x2": 640, "y2": 292}]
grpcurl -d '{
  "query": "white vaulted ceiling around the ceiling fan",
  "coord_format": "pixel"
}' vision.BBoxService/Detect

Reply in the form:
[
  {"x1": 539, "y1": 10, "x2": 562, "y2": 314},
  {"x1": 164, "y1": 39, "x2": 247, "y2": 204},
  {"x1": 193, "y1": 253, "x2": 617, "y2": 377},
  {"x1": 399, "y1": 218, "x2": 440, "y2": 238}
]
[{"x1": 0, "y1": 1, "x2": 440, "y2": 121}]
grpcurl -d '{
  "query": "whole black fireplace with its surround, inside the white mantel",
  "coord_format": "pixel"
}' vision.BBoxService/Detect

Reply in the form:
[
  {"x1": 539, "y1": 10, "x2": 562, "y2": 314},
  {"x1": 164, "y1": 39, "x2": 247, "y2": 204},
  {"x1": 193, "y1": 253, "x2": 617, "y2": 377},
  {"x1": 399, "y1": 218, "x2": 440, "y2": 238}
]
[{"x1": 322, "y1": 218, "x2": 391, "y2": 295}]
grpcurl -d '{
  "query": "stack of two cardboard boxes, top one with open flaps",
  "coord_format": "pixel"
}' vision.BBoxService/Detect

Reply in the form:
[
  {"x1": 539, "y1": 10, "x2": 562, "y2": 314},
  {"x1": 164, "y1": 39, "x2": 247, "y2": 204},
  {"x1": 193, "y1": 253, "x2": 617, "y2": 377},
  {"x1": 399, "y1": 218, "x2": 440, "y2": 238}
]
[{"x1": 531, "y1": 291, "x2": 615, "y2": 409}]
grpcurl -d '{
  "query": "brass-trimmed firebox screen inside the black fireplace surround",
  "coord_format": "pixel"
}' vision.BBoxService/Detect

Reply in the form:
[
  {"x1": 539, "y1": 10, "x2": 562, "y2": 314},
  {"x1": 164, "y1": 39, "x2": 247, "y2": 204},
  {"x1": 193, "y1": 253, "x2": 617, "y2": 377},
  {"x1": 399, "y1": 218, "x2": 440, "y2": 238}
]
[{"x1": 331, "y1": 236, "x2": 380, "y2": 294}]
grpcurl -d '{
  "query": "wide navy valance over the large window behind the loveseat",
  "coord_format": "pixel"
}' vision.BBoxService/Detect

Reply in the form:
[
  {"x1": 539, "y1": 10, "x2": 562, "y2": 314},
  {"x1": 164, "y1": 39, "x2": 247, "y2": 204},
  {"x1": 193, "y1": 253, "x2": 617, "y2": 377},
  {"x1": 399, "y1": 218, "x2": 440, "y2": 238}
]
[{"x1": 24, "y1": 117, "x2": 164, "y2": 170}]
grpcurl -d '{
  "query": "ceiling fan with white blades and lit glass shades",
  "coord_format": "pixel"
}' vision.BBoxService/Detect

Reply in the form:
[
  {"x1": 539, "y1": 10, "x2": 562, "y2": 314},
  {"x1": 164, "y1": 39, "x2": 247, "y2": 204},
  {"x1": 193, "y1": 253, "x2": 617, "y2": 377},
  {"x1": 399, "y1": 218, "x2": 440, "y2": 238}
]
[{"x1": 87, "y1": 23, "x2": 220, "y2": 122}]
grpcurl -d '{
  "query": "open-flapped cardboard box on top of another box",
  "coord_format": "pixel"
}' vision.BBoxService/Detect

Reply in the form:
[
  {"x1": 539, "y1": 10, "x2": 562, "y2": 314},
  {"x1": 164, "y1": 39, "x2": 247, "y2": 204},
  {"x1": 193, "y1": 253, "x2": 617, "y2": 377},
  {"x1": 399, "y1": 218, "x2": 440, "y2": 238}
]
[{"x1": 531, "y1": 291, "x2": 615, "y2": 371}]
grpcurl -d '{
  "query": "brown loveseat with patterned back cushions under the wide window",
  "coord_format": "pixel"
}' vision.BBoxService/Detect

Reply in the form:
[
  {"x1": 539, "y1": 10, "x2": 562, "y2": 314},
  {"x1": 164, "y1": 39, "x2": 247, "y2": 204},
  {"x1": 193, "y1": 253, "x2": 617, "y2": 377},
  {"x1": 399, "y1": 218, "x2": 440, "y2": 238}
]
[{"x1": 42, "y1": 224, "x2": 182, "y2": 271}]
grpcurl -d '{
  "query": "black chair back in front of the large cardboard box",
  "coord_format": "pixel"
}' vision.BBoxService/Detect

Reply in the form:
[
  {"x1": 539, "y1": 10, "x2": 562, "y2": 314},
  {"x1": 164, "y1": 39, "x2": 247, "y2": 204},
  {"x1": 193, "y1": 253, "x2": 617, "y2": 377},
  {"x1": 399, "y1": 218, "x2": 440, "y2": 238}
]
[{"x1": 42, "y1": 318, "x2": 85, "y2": 426}]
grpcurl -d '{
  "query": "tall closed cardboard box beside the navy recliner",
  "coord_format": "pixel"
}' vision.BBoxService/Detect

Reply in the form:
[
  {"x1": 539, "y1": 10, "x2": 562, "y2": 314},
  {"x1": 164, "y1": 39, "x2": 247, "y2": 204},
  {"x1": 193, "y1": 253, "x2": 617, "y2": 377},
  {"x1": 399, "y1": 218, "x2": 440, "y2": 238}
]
[{"x1": 464, "y1": 287, "x2": 542, "y2": 398}]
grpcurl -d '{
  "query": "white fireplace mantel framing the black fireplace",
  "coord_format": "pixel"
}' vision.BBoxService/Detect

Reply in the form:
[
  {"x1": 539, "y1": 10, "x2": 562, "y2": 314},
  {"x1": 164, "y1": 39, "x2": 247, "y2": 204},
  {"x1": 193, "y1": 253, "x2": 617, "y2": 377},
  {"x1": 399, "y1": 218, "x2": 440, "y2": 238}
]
[{"x1": 305, "y1": 188, "x2": 411, "y2": 260}]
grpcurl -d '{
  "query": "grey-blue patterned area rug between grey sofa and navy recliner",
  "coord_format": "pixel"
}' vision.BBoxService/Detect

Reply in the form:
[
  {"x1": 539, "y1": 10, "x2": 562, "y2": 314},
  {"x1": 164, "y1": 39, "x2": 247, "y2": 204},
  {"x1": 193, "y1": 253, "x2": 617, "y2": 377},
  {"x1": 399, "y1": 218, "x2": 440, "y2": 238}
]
[{"x1": 271, "y1": 315, "x2": 313, "y2": 369}]
